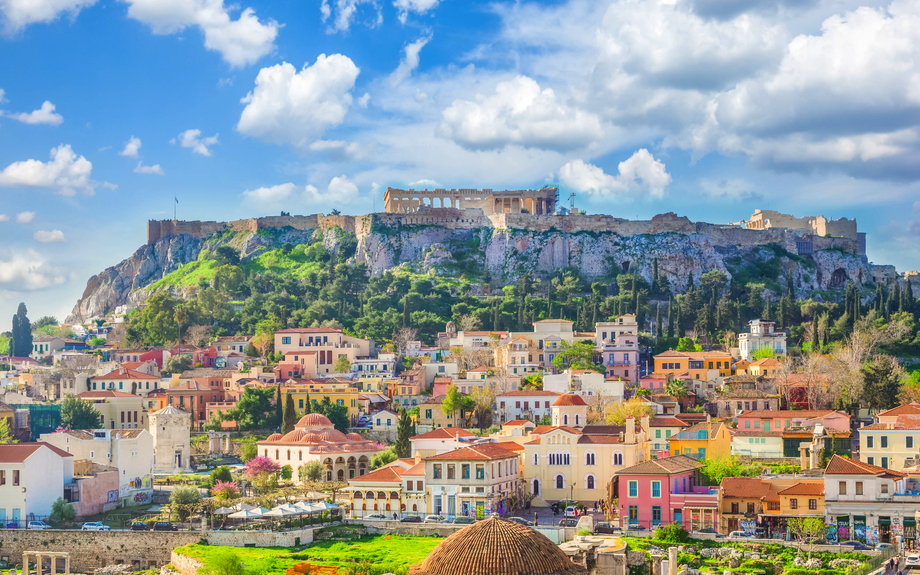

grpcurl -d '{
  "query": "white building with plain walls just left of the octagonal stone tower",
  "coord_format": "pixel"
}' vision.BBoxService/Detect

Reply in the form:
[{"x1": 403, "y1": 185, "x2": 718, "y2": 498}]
[{"x1": 42, "y1": 429, "x2": 153, "y2": 505}]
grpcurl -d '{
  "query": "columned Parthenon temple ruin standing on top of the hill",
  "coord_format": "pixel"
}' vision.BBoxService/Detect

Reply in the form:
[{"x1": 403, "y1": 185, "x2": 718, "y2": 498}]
[{"x1": 383, "y1": 186, "x2": 559, "y2": 216}]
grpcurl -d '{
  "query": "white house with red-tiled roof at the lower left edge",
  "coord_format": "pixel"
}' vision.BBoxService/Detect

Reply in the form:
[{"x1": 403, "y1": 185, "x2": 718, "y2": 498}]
[{"x1": 0, "y1": 442, "x2": 74, "y2": 529}]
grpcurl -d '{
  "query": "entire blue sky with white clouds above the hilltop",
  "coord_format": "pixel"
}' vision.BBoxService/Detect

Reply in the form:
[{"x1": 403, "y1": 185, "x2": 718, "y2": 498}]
[{"x1": 0, "y1": 0, "x2": 920, "y2": 329}]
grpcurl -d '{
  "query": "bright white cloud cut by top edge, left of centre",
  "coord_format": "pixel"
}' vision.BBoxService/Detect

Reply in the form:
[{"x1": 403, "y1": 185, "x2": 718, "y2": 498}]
[{"x1": 125, "y1": 0, "x2": 280, "y2": 67}]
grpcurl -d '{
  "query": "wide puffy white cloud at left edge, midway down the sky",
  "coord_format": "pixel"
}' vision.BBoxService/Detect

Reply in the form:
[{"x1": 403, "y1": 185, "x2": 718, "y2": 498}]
[{"x1": 0, "y1": 144, "x2": 98, "y2": 196}]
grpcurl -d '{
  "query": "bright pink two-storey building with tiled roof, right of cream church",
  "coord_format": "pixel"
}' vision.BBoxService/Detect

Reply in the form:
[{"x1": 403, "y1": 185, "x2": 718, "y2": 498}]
[{"x1": 614, "y1": 455, "x2": 719, "y2": 531}]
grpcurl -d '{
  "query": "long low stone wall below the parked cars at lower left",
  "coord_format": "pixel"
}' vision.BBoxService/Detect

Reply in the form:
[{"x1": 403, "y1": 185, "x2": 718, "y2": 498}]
[{"x1": 0, "y1": 529, "x2": 313, "y2": 573}]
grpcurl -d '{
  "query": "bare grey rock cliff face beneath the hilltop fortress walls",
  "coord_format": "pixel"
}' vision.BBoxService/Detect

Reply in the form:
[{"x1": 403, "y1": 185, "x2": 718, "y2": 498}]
[{"x1": 67, "y1": 216, "x2": 876, "y2": 322}]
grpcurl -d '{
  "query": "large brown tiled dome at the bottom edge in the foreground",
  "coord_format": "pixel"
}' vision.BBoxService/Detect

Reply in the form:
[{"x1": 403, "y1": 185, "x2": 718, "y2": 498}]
[{"x1": 409, "y1": 517, "x2": 585, "y2": 575}]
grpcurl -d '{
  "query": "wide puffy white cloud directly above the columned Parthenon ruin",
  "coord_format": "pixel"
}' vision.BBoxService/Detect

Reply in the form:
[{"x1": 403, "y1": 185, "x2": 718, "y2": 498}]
[{"x1": 438, "y1": 76, "x2": 604, "y2": 151}]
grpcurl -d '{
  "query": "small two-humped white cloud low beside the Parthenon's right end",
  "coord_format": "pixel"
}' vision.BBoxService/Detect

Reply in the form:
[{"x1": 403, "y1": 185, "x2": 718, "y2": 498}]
[{"x1": 559, "y1": 148, "x2": 671, "y2": 199}]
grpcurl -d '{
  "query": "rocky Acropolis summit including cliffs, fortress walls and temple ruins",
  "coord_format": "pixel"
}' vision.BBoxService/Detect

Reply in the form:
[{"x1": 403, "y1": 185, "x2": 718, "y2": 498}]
[{"x1": 72, "y1": 187, "x2": 900, "y2": 317}]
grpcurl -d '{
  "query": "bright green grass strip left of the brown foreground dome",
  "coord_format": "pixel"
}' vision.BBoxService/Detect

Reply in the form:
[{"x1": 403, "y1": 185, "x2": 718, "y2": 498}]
[{"x1": 176, "y1": 535, "x2": 444, "y2": 574}]
